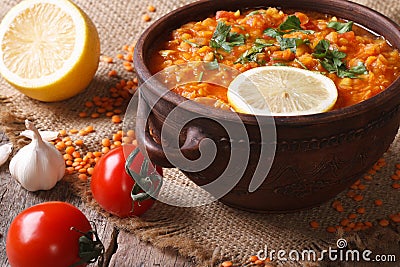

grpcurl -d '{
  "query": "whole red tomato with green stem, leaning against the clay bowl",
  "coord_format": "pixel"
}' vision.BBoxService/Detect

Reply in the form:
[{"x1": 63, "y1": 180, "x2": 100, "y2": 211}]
[{"x1": 90, "y1": 145, "x2": 162, "y2": 218}]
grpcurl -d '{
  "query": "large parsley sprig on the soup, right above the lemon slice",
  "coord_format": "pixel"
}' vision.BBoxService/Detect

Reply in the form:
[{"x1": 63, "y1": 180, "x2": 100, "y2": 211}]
[{"x1": 313, "y1": 40, "x2": 367, "y2": 78}]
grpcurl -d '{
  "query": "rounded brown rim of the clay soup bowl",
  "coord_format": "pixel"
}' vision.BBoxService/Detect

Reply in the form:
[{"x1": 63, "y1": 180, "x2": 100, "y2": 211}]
[{"x1": 134, "y1": 0, "x2": 400, "y2": 126}]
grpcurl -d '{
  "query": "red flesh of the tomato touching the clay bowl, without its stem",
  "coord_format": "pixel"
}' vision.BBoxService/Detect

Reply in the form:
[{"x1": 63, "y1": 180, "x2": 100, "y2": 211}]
[{"x1": 90, "y1": 145, "x2": 162, "y2": 217}]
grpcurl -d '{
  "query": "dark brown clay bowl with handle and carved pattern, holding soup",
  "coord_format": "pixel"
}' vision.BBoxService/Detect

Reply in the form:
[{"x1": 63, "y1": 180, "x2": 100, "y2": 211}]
[{"x1": 134, "y1": 0, "x2": 400, "y2": 212}]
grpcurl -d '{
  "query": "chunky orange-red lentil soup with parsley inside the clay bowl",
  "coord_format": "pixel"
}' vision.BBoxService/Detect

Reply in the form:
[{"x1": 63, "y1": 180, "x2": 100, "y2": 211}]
[{"x1": 152, "y1": 8, "x2": 400, "y2": 109}]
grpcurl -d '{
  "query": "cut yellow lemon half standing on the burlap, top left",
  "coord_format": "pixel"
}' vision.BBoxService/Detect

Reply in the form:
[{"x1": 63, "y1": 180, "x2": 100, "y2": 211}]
[{"x1": 0, "y1": 0, "x2": 100, "y2": 102}]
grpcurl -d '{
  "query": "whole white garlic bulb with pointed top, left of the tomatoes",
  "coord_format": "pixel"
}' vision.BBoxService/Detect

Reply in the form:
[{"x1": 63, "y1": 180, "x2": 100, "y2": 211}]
[{"x1": 9, "y1": 120, "x2": 65, "y2": 191}]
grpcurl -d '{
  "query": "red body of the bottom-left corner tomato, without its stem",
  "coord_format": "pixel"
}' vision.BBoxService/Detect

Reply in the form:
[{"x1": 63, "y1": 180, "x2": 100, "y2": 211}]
[{"x1": 6, "y1": 201, "x2": 102, "y2": 267}]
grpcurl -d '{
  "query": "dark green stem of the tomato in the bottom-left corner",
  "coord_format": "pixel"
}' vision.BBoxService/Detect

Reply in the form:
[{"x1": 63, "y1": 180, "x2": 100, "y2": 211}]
[{"x1": 70, "y1": 223, "x2": 104, "y2": 267}]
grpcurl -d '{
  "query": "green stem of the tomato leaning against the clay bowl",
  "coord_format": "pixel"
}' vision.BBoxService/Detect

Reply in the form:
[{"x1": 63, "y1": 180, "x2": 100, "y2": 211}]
[{"x1": 125, "y1": 148, "x2": 162, "y2": 209}]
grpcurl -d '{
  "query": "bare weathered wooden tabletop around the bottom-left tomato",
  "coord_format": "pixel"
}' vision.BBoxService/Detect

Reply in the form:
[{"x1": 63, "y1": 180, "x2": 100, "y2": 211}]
[{"x1": 0, "y1": 137, "x2": 195, "y2": 267}]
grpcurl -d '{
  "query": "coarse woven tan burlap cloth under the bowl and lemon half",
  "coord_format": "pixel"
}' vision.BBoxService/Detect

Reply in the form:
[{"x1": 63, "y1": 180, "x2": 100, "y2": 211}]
[{"x1": 0, "y1": 0, "x2": 400, "y2": 266}]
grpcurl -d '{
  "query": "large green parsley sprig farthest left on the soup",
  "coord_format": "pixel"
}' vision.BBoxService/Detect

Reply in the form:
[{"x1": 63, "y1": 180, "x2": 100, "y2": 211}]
[{"x1": 210, "y1": 21, "x2": 245, "y2": 52}]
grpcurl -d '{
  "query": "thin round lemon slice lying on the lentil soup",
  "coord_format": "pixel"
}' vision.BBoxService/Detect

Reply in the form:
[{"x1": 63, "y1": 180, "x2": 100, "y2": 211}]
[{"x1": 228, "y1": 66, "x2": 338, "y2": 116}]
